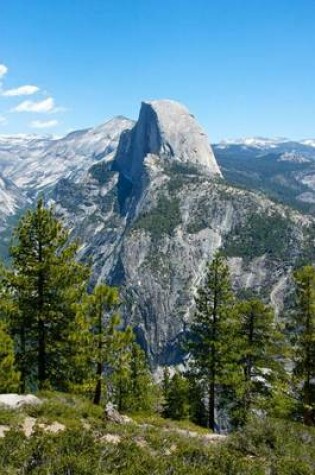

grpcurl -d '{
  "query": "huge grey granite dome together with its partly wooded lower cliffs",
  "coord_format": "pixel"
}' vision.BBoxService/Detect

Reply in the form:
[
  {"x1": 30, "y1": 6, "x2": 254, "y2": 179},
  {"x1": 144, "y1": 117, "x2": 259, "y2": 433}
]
[{"x1": 53, "y1": 101, "x2": 313, "y2": 366}]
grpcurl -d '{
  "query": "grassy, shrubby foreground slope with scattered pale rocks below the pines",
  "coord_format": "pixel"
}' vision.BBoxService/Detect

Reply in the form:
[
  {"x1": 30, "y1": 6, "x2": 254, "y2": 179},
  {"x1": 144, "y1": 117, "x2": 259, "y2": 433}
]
[{"x1": 0, "y1": 394, "x2": 315, "y2": 475}]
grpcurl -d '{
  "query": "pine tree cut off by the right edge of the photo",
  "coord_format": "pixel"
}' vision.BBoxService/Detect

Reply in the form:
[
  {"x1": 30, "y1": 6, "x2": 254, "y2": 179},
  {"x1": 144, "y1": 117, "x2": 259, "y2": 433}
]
[{"x1": 292, "y1": 265, "x2": 315, "y2": 425}]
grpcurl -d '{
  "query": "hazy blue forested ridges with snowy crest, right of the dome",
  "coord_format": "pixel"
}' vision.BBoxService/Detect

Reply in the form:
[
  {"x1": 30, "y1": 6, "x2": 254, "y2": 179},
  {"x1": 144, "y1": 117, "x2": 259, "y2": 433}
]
[{"x1": 214, "y1": 138, "x2": 315, "y2": 214}]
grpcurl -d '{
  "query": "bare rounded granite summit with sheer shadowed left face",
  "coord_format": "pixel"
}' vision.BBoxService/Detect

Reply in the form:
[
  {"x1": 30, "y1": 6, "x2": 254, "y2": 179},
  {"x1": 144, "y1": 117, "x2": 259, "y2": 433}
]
[{"x1": 115, "y1": 100, "x2": 221, "y2": 183}]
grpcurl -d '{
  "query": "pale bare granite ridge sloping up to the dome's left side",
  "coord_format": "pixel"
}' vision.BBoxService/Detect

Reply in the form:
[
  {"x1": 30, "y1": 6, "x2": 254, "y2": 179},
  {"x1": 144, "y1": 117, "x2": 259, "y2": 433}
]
[{"x1": 0, "y1": 117, "x2": 134, "y2": 195}]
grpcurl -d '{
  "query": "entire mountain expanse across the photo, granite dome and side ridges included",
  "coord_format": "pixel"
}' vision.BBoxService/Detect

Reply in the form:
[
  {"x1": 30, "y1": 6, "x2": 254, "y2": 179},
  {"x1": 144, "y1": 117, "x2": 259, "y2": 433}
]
[{"x1": 0, "y1": 104, "x2": 315, "y2": 365}]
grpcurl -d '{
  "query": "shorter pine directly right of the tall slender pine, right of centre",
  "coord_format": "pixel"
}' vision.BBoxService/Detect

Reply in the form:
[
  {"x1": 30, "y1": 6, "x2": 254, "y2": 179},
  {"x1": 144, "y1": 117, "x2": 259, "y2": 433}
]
[{"x1": 237, "y1": 299, "x2": 285, "y2": 423}]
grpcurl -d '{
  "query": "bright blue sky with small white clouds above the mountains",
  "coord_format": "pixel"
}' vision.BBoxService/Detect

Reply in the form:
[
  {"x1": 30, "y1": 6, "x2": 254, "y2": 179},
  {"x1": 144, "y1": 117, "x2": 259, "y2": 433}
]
[{"x1": 0, "y1": 0, "x2": 315, "y2": 141}]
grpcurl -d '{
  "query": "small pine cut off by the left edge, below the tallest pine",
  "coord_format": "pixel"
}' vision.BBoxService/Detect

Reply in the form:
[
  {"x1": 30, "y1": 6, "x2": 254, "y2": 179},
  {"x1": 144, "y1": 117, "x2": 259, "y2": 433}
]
[{"x1": 0, "y1": 321, "x2": 20, "y2": 393}]
